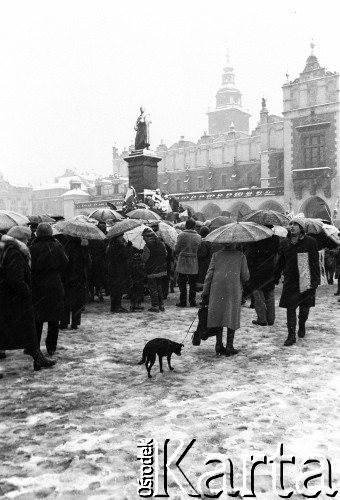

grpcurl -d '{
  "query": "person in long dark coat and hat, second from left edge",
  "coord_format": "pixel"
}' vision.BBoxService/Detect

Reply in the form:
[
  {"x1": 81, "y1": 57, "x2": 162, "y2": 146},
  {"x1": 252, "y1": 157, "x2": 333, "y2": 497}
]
[{"x1": 30, "y1": 222, "x2": 68, "y2": 356}]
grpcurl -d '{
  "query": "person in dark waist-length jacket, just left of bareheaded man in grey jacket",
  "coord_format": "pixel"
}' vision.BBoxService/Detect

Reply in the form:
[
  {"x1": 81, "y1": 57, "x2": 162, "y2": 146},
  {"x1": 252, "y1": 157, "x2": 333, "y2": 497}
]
[{"x1": 142, "y1": 228, "x2": 167, "y2": 313}]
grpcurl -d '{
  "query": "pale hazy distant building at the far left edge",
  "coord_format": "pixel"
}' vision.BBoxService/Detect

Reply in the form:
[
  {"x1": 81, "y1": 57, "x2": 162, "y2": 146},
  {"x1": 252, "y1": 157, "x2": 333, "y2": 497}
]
[{"x1": 0, "y1": 172, "x2": 32, "y2": 215}]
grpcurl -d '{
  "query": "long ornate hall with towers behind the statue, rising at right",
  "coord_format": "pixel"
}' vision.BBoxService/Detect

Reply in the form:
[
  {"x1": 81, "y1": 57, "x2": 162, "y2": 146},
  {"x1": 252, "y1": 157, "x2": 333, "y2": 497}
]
[{"x1": 114, "y1": 44, "x2": 340, "y2": 224}]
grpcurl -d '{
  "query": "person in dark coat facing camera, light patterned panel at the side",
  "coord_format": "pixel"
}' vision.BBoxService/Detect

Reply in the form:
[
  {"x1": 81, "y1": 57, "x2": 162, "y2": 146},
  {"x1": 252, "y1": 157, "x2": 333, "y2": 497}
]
[{"x1": 274, "y1": 217, "x2": 320, "y2": 346}]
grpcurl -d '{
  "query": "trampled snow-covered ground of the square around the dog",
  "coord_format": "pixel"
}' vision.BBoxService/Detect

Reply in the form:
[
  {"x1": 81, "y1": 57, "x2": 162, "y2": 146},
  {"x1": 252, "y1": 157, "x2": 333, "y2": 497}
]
[{"x1": 0, "y1": 285, "x2": 340, "y2": 500}]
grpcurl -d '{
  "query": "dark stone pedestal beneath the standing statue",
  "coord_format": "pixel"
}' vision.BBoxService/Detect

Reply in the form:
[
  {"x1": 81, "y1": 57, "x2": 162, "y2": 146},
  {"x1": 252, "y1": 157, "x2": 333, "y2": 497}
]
[{"x1": 124, "y1": 149, "x2": 162, "y2": 195}]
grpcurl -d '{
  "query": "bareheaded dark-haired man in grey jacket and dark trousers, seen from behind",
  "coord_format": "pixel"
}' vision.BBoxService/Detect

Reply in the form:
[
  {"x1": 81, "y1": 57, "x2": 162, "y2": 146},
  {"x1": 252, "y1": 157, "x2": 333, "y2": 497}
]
[{"x1": 175, "y1": 219, "x2": 202, "y2": 307}]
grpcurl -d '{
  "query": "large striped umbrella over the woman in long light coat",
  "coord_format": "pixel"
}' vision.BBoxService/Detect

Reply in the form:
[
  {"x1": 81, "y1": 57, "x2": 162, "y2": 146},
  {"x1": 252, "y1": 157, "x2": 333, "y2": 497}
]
[{"x1": 205, "y1": 221, "x2": 273, "y2": 243}]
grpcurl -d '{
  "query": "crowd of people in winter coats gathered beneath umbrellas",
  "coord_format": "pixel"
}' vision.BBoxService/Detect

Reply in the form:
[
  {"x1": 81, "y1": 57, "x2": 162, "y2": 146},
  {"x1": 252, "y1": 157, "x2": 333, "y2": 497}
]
[{"x1": 0, "y1": 213, "x2": 340, "y2": 376}]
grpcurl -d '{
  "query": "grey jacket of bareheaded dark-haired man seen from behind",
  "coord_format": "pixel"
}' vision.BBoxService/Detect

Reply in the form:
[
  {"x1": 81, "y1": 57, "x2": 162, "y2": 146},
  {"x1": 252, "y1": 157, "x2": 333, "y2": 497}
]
[{"x1": 175, "y1": 229, "x2": 202, "y2": 274}]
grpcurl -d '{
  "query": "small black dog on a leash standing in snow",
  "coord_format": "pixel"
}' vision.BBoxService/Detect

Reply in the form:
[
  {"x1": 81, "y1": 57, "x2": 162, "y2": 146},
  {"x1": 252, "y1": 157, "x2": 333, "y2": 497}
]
[{"x1": 138, "y1": 338, "x2": 184, "y2": 378}]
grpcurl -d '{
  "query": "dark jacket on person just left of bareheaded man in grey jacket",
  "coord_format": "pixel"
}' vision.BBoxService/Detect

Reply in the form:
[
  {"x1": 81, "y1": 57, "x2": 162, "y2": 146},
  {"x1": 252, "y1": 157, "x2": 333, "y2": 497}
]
[{"x1": 142, "y1": 234, "x2": 167, "y2": 278}]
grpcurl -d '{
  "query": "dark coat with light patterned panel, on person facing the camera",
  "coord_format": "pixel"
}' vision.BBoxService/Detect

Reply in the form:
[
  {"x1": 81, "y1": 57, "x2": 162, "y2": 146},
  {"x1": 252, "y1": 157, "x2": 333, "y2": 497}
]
[{"x1": 274, "y1": 235, "x2": 320, "y2": 308}]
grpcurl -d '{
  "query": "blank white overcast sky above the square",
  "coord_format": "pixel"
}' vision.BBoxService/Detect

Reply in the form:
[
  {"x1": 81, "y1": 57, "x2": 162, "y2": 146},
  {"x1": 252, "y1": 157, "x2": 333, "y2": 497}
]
[{"x1": 0, "y1": 0, "x2": 340, "y2": 185}]
